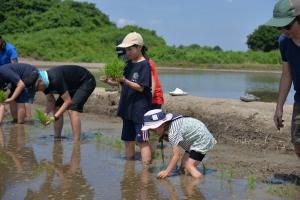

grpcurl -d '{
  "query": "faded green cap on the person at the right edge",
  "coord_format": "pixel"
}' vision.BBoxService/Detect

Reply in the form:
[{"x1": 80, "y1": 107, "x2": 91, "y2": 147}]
[{"x1": 265, "y1": 0, "x2": 300, "y2": 27}]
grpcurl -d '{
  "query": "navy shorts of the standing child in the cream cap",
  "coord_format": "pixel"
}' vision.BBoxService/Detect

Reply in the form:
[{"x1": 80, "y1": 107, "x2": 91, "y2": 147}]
[{"x1": 121, "y1": 119, "x2": 149, "y2": 142}]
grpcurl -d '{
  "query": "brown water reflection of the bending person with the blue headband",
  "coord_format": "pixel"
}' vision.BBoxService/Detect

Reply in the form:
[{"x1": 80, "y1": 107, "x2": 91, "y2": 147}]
[{"x1": 26, "y1": 141, "x2": 94, "y2": 199}]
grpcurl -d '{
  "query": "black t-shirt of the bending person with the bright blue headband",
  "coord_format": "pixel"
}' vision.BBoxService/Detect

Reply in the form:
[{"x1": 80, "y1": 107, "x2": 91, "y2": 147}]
[{"x1": 44, "y1": 65, "x2": 93, "y2": 95}]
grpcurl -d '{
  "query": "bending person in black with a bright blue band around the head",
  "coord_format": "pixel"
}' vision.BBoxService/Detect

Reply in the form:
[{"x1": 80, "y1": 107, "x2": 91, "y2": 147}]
[{"x1": 34, "y1": 65, "x2": 96, "y2": 141}]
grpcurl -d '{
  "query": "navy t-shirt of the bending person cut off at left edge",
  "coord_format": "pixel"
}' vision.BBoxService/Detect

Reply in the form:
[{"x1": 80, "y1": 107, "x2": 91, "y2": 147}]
[{"x1": 0, "y1": 63, "x2": 38, "y2": 87}]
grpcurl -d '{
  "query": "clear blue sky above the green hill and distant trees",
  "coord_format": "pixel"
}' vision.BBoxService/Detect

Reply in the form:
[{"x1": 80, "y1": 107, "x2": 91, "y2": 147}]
[{"x1": 81, "y1": 0, "x2": 276, "y2": 51}]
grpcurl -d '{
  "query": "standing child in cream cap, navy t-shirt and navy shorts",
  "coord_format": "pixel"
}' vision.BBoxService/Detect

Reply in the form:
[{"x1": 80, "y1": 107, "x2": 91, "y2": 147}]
[{"x1": 101, "y1": 32, "x2": 152, "y2": 165}]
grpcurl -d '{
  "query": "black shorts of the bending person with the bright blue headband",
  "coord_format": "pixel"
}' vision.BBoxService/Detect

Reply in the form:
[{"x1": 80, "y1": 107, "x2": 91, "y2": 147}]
[{"x1": 55, "y1": 77, "x2": 96, "y2": 112}]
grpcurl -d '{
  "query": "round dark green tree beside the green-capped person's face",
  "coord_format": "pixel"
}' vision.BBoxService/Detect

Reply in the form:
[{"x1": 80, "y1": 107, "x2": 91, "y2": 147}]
[{"x1": 247, "y1": 25, "x2": 280, "y2": 52}]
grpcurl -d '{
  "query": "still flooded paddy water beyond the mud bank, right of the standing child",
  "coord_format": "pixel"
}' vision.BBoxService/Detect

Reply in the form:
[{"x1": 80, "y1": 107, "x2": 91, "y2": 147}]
[{"x1": 159, "y1": 71, "x2": 294, "y2": 104}]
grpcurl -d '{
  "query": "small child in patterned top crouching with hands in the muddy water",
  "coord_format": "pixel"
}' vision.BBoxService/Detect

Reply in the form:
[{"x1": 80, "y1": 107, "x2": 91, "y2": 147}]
[{"x1": 142, "y1": 109, "x2": 217, "y2": 178}]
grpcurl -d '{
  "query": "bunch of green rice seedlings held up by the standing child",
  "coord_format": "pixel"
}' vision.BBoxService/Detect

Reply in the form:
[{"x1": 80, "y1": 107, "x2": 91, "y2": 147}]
[{"x1": 104, "y1": 58, "x2": 126, "y2": 80}]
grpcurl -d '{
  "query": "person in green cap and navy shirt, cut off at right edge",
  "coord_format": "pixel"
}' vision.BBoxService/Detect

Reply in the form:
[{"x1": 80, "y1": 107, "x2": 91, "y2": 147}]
[{"x1": 265, "y1": 0, "x2": 300, "y2": 158}]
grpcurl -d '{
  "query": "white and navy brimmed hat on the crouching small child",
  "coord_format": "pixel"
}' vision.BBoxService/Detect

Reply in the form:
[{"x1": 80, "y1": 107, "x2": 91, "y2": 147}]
[{"x1": 141, "y1": 109, "x2": 173, "y2": 131}]
